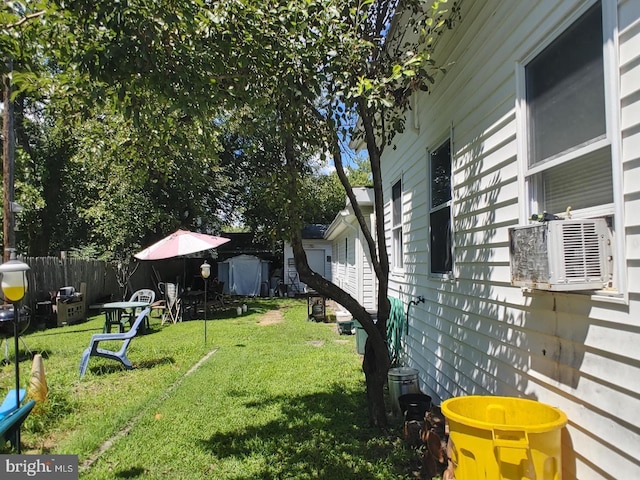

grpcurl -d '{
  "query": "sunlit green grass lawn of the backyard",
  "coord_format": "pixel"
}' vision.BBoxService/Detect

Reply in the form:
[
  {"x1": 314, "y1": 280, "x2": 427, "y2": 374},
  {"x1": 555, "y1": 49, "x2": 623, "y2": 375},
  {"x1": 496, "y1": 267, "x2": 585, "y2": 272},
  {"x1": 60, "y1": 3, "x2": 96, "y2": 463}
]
[{"x1": 0, "y1": 299, "x2": 417, "y2": 480}]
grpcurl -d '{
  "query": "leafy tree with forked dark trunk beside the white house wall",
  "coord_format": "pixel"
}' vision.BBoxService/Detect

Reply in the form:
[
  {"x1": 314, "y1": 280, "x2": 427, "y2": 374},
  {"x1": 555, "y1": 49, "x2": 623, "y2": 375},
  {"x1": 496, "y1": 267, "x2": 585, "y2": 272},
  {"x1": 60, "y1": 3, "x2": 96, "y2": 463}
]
[{"x1": 0, "y1": 0, "x2": 457, "y2": 425}]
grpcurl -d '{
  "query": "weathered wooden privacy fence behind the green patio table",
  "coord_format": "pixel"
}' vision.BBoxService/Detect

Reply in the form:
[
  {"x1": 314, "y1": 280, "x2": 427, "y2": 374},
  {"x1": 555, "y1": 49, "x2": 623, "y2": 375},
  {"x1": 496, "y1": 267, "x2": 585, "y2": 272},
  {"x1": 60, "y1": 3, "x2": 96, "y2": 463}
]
[{"x1": 18, "y1": 256, "x2": 119, "y2": 311}]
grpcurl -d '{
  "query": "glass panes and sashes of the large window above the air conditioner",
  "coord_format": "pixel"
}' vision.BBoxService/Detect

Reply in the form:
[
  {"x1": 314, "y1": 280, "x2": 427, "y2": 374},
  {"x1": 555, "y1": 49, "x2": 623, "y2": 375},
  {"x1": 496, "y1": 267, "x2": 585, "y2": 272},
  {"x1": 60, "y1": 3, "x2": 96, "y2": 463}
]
[{"x1": 524, "y1": 2, "x2": 613, "y2": 218}]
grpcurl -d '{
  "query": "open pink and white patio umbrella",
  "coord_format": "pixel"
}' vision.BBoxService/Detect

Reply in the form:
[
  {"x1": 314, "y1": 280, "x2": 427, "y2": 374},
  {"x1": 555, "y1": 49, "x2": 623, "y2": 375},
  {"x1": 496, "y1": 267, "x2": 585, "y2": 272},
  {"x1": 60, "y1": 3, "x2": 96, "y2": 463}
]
[{"x1": 134, "y1": 230, "x2": 231, "y2": 260}]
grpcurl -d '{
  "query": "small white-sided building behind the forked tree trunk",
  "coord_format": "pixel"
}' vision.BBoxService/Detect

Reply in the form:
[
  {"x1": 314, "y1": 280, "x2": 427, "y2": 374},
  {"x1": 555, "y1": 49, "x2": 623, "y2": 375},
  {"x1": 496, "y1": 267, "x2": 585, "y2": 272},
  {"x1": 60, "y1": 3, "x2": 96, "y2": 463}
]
[{"x1": 325, "y1": 187, "x2": 377, "y2": 310}]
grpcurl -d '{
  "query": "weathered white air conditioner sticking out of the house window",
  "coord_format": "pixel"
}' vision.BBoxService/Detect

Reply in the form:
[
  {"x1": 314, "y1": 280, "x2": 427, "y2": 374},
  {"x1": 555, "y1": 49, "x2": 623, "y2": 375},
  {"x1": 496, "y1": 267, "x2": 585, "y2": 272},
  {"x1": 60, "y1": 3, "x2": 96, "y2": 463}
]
[{"x1": 509, "y1": 218, "x2": 609, "y2": 291}]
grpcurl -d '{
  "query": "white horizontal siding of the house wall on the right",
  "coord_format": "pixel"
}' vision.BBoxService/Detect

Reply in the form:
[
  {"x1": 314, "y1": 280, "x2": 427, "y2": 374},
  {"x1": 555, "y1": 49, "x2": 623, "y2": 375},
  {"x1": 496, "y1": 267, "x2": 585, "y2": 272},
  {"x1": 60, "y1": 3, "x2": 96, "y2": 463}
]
[{"x1": 382, "y1": 0, "x2": 640, "y2": 479}]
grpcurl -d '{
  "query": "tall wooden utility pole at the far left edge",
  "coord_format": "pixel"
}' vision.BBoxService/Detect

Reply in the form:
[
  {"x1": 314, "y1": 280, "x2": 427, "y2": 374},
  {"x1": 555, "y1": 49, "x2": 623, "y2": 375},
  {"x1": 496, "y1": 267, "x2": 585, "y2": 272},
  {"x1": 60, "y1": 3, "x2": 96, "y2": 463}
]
[{"x1": 2, "y1": 59, "x2": 16, "y2": 262}]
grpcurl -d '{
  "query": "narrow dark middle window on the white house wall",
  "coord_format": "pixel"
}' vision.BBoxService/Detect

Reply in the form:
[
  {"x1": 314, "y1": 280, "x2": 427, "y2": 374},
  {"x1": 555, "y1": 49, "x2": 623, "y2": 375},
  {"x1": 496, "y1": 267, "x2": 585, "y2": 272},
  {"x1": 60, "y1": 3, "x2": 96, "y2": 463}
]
[{"x1": 429, "y1": 140, "x2": 453, "y2": 275}]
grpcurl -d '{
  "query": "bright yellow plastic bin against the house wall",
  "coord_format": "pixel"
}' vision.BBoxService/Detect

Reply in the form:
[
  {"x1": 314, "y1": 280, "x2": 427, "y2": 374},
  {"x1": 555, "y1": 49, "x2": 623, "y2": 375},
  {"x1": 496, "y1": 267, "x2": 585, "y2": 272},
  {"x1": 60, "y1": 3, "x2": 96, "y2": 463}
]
[{"x1": 442, "y1": 396, "x2": 567, "y2": 480}]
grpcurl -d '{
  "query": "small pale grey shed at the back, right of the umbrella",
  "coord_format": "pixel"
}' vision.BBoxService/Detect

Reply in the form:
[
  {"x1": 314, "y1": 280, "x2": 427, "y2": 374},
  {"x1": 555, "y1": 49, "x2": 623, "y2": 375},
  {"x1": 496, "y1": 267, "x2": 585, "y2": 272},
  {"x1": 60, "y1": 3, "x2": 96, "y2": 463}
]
[{"x1": 218, "y1": 255, "x2": 269, "y2": 297}]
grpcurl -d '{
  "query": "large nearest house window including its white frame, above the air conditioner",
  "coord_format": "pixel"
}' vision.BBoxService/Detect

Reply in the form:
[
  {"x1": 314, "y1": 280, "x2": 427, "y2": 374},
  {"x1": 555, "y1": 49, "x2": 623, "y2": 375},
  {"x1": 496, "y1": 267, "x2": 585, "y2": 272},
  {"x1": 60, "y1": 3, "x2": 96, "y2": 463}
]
[{"x1": 519, "y1": 1, "x2": 622, "y2": 290}]
